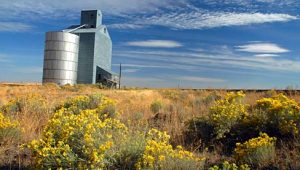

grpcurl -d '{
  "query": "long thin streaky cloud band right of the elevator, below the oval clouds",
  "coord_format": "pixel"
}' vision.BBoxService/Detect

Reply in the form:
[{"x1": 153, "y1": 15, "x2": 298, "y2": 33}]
[{"x1": 114, "y1": 46, "x2": 300, "y2": 74}]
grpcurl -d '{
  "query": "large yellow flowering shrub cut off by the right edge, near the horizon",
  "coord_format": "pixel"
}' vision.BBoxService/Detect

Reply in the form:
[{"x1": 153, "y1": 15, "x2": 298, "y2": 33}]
[{"x1": 256, "y1": 94, "x2": 300, "y2": 136}]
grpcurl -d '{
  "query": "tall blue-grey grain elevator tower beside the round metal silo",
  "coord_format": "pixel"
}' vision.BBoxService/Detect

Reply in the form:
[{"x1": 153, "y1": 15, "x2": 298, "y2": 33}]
[{"x1": 43, "y1": 10, "x2": 118, "y2": 86}]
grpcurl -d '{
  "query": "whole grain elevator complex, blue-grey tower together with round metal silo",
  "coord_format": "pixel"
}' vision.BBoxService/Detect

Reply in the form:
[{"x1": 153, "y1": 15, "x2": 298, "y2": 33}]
[{"x1": 43, "y1": 10, "x2": 118, "y2": 87}]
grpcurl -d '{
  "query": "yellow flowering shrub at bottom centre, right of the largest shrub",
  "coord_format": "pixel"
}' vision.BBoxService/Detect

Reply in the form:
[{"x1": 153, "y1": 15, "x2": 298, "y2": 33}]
[{"x1": 136, "y1": 129, "x2": 205, "y2": 169}]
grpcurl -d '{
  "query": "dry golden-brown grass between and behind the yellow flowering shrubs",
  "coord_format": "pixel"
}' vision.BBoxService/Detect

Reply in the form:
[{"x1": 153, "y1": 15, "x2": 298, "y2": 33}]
[{"x1": 0, "y1": 84, "x2": 300, "y2": 167}]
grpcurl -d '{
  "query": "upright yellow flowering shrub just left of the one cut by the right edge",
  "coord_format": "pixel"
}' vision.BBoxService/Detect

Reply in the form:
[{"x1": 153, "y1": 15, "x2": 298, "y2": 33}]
[{"x1": 209, "y1": 92, "x2": 247, "y2": 139}]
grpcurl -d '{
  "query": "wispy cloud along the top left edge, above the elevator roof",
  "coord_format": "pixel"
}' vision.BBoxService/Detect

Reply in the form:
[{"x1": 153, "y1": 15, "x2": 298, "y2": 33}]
[{"x1": 0, "y1": 0, "x2": 174, "y2": 18}]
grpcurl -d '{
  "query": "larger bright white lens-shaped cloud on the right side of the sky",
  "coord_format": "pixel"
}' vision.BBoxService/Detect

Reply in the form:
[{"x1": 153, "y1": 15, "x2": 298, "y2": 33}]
[{"x1": 236, "y1": 43, "x2": 289, "y2": 53}]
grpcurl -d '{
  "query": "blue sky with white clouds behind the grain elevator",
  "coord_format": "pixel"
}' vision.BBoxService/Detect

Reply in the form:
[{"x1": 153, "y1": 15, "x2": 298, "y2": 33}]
[{"x1": 0, "y1": 0, "x2": 300, "y2": 89}]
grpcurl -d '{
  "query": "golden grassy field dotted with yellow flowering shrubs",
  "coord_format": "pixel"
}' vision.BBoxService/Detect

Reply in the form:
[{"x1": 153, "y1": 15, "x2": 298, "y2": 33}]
[{"x1": 0, "y1": 84, "x2": 300, "y2": 170}]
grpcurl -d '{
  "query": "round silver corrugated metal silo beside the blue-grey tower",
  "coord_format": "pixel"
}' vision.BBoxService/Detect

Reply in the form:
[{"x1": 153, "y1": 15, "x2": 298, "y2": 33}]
[{"x1": 43, "y1": 32, "x2": 79, "y2": 85}]
